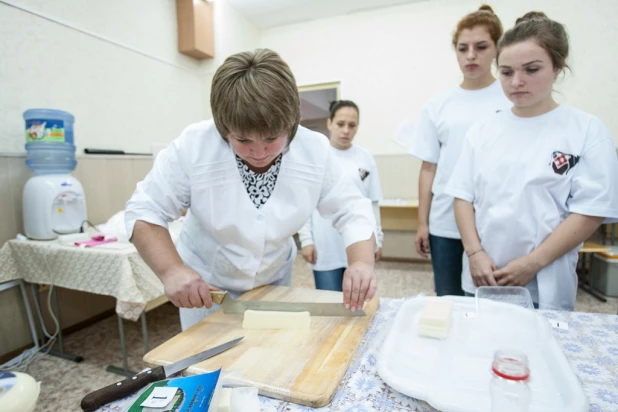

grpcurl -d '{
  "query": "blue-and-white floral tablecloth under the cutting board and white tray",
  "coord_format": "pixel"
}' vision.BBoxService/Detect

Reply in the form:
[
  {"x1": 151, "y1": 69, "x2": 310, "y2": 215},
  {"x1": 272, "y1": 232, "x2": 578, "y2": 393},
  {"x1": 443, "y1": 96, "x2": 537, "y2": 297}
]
[{"x1": 260, "y1": 298, "x2": 618, "y2": 412}]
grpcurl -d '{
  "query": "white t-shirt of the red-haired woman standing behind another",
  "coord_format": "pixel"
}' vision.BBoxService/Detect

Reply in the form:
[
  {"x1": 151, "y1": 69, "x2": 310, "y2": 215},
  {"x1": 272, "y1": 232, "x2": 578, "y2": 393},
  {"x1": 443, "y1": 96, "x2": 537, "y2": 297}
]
[{"x1": 409, "y1": 81, "x2": 512, "y2": 239}]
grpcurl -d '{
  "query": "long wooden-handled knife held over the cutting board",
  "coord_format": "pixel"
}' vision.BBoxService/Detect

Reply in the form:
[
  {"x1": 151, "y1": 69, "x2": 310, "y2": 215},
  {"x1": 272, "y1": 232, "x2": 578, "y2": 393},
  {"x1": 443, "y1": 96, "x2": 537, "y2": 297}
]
[{"x1": 210, "y1": 291, "x2": 366, "y2": 316}]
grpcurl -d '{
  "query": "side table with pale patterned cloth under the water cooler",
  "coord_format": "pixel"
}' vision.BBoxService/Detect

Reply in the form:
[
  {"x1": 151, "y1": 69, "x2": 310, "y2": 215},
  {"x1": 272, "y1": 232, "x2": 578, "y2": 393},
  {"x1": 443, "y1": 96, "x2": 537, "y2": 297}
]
[{"x1": 0, "y1": 240, "x2": 166, "y2": 376}]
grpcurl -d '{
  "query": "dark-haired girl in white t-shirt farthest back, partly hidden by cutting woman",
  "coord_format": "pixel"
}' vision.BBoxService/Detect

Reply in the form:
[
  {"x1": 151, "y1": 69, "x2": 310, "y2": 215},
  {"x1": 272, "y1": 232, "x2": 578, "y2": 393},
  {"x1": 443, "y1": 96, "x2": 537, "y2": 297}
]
[{"x1": 298, "y1": 100, "x2": 384, "y2": 291}]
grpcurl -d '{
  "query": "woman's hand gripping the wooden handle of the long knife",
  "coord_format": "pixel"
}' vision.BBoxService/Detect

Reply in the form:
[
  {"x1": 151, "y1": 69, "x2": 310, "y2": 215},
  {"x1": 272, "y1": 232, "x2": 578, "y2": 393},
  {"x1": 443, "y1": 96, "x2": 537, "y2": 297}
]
[{"x1": 160, "y1": 264, "x2": 219, "y2": 309}]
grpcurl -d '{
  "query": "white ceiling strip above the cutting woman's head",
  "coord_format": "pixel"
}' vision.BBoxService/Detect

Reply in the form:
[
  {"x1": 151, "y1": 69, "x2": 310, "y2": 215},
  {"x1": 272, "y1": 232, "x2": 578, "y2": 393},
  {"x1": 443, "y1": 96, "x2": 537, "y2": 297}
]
[{"x1": 223, "y1": 0, "x2": 428, "y2": 29}]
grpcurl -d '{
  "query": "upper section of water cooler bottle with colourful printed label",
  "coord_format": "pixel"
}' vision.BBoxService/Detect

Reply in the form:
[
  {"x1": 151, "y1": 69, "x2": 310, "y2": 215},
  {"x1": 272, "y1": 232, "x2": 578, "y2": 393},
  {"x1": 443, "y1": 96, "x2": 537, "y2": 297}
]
[{"x1": 24, "y1": 109, "x2": 75, "y2": 144}]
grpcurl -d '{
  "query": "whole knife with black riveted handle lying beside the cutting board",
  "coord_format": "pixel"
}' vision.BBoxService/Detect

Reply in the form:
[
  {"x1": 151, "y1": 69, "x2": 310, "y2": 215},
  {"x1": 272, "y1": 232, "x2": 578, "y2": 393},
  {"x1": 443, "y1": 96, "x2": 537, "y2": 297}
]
[{"x1": 81, "y1": 337, "x2": 243, "y2": 412}]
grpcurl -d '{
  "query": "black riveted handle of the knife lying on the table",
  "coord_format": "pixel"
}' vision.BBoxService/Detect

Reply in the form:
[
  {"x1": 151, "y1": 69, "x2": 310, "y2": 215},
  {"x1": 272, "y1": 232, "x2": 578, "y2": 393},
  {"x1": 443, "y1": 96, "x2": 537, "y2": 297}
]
[{"x1": 81, "y1": 366, "x2": 166, "y2": 412}]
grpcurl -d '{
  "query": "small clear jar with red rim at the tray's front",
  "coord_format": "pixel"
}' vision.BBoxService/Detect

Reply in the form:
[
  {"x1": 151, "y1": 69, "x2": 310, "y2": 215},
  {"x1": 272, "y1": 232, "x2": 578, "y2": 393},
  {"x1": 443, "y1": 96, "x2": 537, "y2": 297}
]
[{"x1": 489, "y1": 350, "x2": 531, "y2": 412}]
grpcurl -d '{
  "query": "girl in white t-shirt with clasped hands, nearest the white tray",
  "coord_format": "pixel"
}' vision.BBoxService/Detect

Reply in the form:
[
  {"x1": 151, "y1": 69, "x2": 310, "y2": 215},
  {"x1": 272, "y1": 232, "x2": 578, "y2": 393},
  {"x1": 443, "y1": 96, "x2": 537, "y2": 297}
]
[{"x1": 447, "y1": 12, "x2": 618, "y2": 310}]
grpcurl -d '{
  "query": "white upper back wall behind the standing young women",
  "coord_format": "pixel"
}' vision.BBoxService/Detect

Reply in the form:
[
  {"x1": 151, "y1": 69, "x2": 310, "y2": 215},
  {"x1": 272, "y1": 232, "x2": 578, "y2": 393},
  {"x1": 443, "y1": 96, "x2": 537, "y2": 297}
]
[{"x1": 260, "y1": 0, "x2": 618, "y2": 160}]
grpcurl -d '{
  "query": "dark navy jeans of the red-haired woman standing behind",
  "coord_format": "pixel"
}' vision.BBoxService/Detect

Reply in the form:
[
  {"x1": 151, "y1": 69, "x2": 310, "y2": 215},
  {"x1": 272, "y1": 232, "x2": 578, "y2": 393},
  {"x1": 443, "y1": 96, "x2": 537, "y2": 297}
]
[{"x1": 429, "y1": 234, "x2": 464, "y2": 296}]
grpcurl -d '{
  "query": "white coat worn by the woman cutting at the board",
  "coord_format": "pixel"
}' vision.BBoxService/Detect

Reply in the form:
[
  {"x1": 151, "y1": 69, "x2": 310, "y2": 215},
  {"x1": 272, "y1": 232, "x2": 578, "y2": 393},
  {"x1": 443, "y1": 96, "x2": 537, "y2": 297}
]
[{"x1": 126, "y1": 121, "x2": 375, "y2": 328}]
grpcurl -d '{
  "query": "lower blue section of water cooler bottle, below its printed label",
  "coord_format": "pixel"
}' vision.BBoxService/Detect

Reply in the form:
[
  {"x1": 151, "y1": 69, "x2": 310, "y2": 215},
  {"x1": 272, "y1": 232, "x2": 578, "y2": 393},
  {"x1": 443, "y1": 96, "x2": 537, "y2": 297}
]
[{"x1": 26, "y1": 142, "x2": 77, "y2": 175}]
